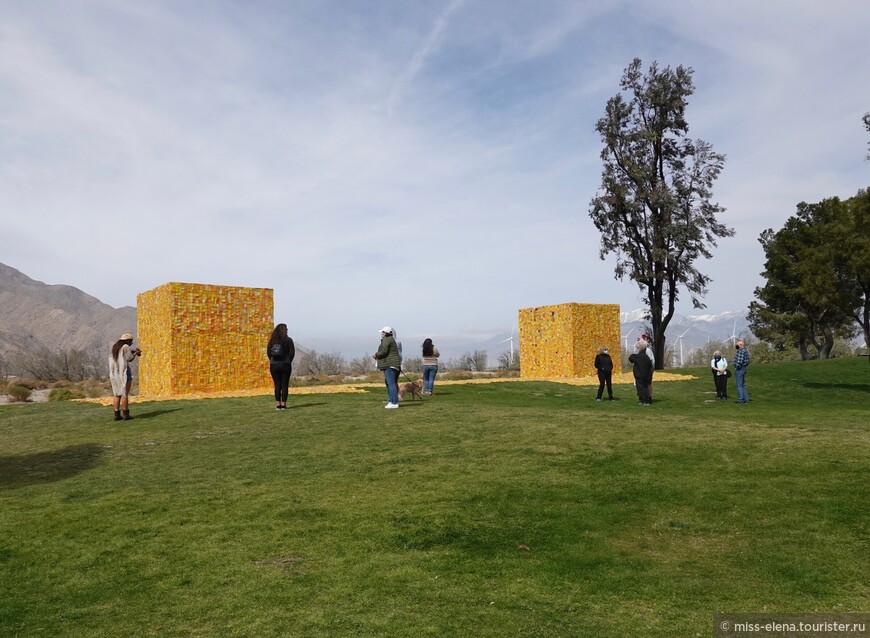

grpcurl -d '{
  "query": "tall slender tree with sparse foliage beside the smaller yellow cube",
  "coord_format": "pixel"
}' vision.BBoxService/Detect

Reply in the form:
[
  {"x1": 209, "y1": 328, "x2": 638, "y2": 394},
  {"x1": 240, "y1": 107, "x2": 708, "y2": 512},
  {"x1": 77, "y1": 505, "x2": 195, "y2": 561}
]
[{"x1": 589, "y1": 58, "x2": 734, "y2": 376}]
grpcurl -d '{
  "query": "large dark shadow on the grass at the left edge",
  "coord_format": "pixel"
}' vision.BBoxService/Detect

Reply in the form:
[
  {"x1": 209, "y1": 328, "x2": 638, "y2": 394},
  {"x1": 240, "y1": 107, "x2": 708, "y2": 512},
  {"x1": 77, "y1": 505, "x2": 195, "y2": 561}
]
[{"x1": 0, "y1": 443, "x2": 105, "y2": 488}]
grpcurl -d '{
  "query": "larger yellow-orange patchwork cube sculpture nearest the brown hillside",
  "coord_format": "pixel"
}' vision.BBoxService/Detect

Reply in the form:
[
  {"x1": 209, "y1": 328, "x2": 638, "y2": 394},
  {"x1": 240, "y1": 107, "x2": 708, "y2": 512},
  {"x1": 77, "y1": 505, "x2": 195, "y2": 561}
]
[{"x1": 136, "y1": 282, "x2": 274, "y2": 396}]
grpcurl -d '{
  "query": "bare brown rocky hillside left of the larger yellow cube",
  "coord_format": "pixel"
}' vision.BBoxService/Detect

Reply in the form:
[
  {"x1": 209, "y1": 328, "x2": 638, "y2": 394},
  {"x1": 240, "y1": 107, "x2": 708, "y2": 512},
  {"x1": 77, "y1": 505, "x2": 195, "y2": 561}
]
[{"x1": 0, "y1": 264, "x2": 136, "y2": 359}]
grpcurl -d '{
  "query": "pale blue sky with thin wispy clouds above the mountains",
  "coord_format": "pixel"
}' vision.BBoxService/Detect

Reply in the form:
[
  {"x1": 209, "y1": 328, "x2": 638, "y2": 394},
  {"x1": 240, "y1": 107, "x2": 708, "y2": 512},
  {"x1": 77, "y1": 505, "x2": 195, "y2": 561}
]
[{"x1": 0, "y1": 0, "x2": 870, "y2": 350}]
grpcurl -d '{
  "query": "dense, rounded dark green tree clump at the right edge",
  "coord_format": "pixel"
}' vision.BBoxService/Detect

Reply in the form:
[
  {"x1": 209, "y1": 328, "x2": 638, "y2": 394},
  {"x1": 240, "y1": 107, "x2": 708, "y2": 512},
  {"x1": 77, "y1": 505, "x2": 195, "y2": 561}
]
[{"x1": 749, "y1": 191, "x2": 870, "y2": 359}]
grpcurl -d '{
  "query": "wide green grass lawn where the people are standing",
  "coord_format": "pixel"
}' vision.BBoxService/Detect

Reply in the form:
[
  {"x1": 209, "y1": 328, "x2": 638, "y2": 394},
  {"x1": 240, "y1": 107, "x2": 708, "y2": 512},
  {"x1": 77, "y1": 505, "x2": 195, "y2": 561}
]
[{"x1": 0, "y1": 358, "x2": 870, "y2": 638}]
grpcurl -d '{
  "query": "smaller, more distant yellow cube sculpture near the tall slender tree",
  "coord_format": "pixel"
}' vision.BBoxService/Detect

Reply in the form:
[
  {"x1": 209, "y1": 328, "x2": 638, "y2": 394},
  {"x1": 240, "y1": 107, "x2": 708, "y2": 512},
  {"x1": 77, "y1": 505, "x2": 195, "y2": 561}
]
[{"x1": 519, "y1": 303, "x2": 621, "y2": 379}]
